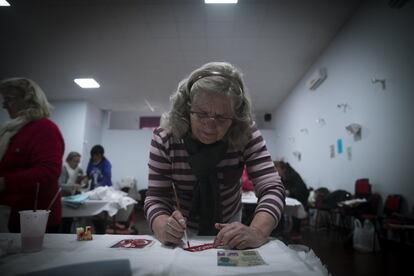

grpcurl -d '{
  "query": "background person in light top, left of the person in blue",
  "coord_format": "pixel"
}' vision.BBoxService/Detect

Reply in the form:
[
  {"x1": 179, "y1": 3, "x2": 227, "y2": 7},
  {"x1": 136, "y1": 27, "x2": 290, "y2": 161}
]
[{"x1": 59, "y1": 151, "x2": 86, "y2": 196}]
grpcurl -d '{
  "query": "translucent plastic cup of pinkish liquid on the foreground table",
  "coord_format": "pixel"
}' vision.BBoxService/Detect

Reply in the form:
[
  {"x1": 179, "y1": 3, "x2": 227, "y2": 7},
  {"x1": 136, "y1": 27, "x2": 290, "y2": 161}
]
[{"x1": 19, "y1": 210, "x2": 50, "y2": 253}]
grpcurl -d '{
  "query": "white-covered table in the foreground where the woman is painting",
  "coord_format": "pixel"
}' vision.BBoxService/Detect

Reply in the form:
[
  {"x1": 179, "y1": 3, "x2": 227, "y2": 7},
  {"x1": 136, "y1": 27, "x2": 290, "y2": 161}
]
[{"x1": 0, "y1": 233, "x2": 328, "y2": 276}]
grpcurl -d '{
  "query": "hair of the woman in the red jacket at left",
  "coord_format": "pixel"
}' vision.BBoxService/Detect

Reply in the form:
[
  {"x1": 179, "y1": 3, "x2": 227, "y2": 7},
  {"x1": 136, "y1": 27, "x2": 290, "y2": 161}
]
[{"x1": 0, "y1": 78, "x2": 53, "y2": 121}]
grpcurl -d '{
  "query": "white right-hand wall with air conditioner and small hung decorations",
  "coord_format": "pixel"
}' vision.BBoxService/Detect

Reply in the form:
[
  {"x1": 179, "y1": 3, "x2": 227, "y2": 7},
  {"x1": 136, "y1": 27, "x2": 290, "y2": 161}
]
[{"x1": 272, "y1": 1, "x2": 414, "y2": 211}]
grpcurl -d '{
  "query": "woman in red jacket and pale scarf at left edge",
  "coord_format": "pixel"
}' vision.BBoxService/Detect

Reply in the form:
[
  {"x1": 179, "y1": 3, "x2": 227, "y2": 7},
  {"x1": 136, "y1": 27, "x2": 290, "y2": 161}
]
[{"x1": 0, "y1": 78, "x2": 64, "y2": 232}]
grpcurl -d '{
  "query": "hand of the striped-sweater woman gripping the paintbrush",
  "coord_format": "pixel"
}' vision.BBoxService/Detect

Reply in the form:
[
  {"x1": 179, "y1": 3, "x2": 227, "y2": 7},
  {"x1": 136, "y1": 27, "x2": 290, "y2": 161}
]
[{"x1": 153, "y1": 211, "x2": 187, "y2": 245}]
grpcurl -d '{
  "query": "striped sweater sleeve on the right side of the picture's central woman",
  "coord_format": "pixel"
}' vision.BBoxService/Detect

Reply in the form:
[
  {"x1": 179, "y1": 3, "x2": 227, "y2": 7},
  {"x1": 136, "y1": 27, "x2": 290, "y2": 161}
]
[{"x1": 244, "y1": 126, "x2": 285, "y2": 223}]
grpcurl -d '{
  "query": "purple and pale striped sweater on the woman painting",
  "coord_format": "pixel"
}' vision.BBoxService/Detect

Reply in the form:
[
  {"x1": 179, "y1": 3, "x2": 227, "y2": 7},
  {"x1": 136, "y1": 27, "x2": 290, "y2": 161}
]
[{"x1": 144, "y1": 127, "x2": 285, "y2": 229}]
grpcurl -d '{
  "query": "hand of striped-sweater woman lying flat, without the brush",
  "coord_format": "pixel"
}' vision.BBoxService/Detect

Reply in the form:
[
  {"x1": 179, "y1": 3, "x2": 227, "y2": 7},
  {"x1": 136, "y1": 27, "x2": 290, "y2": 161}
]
[{"x1": 214, "y1": 222, "x2": 267, "y2": 249}]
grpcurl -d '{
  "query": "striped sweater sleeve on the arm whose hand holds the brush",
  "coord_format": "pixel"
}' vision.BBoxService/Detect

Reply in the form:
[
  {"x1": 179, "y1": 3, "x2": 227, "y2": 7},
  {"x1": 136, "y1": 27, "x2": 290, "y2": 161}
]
[{"x1": 144, "y1": 129, "x2": 174, "y2": 229}]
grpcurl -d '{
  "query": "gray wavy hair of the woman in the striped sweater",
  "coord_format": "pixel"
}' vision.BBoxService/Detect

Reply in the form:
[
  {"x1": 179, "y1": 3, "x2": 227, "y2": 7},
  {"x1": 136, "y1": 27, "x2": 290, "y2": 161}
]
[{"x1": 160, "y1": 62, "x2": 252, "y2": 149}]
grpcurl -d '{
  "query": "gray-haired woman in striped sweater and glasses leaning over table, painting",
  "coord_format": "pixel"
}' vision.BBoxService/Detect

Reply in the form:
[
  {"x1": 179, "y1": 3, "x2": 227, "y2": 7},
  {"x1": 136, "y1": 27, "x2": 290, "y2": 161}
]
[{"x1": 144, "y1": 62, "x2": 285, "y2": 249}]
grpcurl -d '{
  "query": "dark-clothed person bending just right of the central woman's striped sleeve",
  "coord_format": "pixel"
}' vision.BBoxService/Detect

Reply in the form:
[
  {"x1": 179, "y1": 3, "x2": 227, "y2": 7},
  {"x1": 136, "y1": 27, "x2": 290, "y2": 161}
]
[{"x1": 274, "y1": 161, "x2": 309, "y2": 235}]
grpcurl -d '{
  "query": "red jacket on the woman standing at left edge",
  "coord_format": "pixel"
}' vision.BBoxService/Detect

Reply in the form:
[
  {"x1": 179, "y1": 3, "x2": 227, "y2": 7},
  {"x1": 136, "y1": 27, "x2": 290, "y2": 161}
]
[{"x1": 0, "y1": 118, "x2": 65, "y2": 232}]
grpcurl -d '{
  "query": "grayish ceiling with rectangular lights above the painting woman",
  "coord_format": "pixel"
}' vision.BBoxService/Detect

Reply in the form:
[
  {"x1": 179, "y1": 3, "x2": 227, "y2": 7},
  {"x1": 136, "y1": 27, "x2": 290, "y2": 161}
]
[{"x1": 0, "y1": 0, "x2": 361, "y2": 115}]
